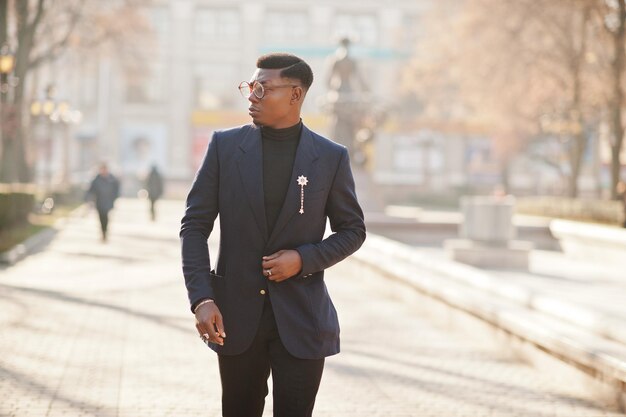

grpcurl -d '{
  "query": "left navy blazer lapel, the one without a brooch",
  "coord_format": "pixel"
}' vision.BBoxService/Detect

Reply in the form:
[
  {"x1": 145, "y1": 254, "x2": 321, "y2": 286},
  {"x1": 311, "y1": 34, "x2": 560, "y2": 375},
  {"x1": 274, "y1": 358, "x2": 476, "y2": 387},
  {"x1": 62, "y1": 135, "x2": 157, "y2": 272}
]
[{"x1": 238, "y1": 125, "x2": 268, "y2": 241}]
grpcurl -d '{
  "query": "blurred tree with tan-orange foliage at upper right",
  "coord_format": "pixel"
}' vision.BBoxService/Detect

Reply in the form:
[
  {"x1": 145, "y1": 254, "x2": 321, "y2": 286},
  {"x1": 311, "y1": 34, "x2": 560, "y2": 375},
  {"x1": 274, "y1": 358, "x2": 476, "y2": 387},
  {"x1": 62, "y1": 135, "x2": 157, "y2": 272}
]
[{"x1": 404, "y1": 0, "x2": 594, "y2": 196}]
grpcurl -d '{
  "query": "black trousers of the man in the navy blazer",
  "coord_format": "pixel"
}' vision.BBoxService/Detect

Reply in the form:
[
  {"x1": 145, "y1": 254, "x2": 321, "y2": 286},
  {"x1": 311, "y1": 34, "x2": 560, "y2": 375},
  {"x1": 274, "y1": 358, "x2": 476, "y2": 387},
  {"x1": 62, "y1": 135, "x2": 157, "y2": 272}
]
[{"x1": 219, "y1": 297, "x2": 324, "y2": 417}]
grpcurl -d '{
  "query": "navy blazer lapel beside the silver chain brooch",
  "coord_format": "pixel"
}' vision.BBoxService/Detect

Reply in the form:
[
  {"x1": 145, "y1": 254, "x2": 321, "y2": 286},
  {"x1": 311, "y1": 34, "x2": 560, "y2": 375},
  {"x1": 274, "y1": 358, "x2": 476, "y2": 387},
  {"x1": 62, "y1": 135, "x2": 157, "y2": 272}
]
[{"x1": 261, "y1": 125, "x2": 319, "y2": 244}]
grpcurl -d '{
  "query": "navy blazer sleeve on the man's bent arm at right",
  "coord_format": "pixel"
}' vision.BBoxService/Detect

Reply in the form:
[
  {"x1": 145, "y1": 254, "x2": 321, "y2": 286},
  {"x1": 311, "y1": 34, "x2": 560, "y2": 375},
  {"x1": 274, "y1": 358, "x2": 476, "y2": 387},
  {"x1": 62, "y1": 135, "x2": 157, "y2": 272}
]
[{"x1": 296, "y1": 148, "x2": 366, "y2": 276}]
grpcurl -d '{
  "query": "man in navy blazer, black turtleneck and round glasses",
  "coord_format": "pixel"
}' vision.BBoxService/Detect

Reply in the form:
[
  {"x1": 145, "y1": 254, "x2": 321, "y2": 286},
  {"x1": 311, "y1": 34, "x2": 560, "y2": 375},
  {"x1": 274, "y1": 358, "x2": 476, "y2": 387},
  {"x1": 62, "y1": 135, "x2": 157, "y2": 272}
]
[{"x1": 180, "y1": 54, "x2": 365, "y2": 417}]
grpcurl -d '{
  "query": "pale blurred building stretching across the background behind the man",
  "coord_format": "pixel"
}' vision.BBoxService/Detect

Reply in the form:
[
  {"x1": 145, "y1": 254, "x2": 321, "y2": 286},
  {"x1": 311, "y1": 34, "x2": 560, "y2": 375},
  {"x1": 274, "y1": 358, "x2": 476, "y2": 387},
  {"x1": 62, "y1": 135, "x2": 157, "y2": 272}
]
[{"x1": 28, "y1": 0, "x2": 626, "y2": 200}]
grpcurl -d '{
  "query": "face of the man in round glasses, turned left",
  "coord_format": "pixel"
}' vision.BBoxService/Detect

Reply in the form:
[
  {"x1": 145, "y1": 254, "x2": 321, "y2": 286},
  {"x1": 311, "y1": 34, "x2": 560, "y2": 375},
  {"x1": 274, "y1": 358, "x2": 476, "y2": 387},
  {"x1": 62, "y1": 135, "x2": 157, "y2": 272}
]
[{"x1": 248, "y1": 68, "x2": 302, "y2": 129}]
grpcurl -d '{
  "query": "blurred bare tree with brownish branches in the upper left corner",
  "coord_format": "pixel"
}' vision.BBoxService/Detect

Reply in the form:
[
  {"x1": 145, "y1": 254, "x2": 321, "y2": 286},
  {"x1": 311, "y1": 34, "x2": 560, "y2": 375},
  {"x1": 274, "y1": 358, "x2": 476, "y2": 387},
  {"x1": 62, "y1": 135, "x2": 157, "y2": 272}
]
[{"x1": 0, "y1": 0, "x2": 150, "y2": 182}]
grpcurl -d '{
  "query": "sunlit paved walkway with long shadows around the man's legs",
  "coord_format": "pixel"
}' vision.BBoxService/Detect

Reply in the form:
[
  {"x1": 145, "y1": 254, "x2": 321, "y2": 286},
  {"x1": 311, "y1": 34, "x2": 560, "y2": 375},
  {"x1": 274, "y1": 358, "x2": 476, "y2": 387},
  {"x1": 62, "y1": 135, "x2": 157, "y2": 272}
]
[{"x1": 0, "y1": 200, "x2": 623, "y2": 417}]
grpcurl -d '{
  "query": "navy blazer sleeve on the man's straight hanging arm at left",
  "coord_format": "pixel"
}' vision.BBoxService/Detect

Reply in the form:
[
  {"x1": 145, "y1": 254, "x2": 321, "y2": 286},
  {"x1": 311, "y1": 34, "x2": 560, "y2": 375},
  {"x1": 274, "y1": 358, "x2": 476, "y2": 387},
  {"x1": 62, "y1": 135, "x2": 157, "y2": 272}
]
[{"x1": 180, "y1": 133, "x2": 219, "y2": 311}]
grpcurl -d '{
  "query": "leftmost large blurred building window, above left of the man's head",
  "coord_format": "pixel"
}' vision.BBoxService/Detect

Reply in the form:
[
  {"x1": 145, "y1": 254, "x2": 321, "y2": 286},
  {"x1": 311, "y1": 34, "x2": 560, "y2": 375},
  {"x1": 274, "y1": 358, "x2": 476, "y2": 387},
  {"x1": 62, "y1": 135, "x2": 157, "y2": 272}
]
[{"x1": 193, "y1": 9, "x2": 241, "y2": 43}]
